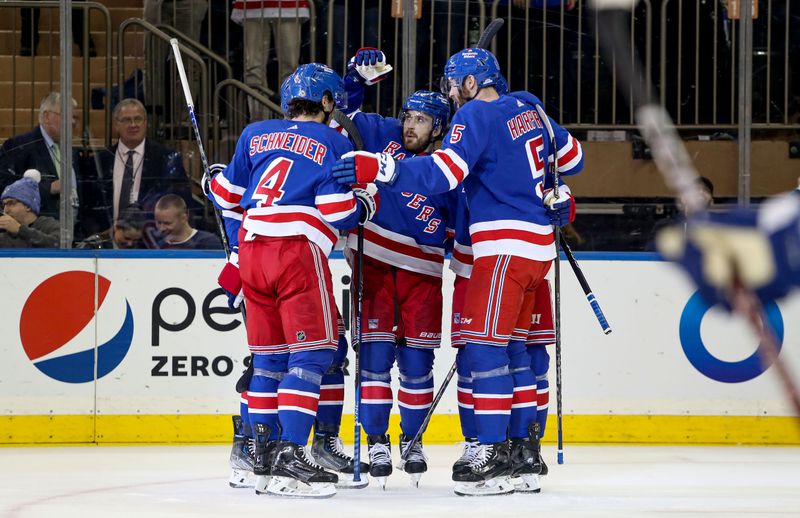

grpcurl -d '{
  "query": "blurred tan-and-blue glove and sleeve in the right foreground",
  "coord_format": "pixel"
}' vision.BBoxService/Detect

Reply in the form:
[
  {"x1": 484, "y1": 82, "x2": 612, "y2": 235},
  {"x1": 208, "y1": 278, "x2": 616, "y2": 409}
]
[{"x1": 656, "y1": 194, "x2": 800, "y2": 308}]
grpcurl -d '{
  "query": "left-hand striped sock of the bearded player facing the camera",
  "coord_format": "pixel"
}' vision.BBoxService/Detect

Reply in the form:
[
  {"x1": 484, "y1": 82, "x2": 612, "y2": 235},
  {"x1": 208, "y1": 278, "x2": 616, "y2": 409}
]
[{"x1": 359, "y1": 342, "x2": 394, "y2": 435}]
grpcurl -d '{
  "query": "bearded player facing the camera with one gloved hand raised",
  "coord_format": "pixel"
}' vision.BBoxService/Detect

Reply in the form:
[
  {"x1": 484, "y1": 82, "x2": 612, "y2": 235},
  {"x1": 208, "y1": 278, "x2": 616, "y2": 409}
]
[{"x1": 334, "y1": 49, "x2": 452, "y2": 485}]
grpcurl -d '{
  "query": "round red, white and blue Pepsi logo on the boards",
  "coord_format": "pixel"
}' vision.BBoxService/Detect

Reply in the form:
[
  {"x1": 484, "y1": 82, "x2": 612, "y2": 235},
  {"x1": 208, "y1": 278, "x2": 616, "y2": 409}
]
[{"x1": 19, "y1": 271, "x2": 133, "y2": 383}]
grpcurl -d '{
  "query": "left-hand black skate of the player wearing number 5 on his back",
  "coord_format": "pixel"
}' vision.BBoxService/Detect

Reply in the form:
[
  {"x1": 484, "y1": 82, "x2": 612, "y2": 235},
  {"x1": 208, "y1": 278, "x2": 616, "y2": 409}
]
[{"x1": 453, "y1": 442, "x2": 514, "y2": 496}]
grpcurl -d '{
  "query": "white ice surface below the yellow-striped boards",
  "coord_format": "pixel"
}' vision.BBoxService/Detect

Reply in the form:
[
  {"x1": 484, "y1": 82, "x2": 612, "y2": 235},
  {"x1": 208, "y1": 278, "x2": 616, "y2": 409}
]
[{"x1": 0, "y1": 445, "x2": 800, "y2": 518}]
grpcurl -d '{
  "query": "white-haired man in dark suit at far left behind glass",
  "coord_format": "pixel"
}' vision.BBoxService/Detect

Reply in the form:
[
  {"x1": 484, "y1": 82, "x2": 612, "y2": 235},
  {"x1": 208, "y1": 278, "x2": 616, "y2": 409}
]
[{"x1": 0, "y1": 92, "x2": 80, "y2": 219}]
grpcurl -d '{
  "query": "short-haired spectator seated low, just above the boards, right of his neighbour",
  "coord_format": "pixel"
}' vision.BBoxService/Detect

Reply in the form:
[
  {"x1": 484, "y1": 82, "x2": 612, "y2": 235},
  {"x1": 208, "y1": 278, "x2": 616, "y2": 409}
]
[{"x1": 155, "y1": 194, "x2": 222, "y2": 250}]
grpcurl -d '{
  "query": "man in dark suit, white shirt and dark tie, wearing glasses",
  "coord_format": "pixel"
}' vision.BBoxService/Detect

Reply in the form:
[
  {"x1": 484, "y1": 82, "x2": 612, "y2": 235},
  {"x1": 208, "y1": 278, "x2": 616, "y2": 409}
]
[{"x1": 85, "y1": 99, "x2": 191, "y2": 230}]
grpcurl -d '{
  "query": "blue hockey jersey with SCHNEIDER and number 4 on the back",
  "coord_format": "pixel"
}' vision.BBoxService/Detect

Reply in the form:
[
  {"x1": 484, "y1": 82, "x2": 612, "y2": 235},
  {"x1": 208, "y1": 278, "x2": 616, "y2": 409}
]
[{"x1": 209, "y1": 119, "x2": 359, "y2": 255}]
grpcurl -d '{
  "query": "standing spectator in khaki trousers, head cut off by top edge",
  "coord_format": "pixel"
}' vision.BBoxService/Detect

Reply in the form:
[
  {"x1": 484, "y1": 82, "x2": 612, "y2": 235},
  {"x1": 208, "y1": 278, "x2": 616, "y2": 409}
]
[{"x1": 231, "y1": 0, "x2": 310, "y2": 120}]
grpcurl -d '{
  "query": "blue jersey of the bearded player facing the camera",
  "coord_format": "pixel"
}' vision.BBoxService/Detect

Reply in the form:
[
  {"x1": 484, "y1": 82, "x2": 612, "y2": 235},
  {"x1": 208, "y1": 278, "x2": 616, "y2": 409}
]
[{"x1": 334, "y1": 112, "x2": 452, "y2": 277}]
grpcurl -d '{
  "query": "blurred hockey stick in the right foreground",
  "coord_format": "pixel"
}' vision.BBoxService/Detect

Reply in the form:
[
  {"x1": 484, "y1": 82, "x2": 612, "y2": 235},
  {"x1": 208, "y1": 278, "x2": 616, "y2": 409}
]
[{"x1": 593, "y1": 0, "x2": 800, "y2": 416}]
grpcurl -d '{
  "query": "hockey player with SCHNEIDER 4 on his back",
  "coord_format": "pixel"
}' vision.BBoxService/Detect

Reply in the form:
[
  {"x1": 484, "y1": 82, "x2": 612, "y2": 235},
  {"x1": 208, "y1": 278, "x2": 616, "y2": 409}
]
[{"x1": 211, "y1": 63, "x2": 375, "y2": 498}]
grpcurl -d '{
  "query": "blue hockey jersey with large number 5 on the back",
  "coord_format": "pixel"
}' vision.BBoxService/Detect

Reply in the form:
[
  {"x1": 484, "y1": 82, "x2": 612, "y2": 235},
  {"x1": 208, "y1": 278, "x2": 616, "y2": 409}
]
[{"x1": 381, "y1": 92, "x2": 583, "y2": 261}]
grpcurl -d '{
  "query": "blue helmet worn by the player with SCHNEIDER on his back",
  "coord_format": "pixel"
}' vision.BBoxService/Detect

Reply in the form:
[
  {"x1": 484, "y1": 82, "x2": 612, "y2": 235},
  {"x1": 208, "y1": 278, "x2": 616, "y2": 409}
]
[{"x1": 281, "y1": 63, "x2": 347, "y2": 113}]
